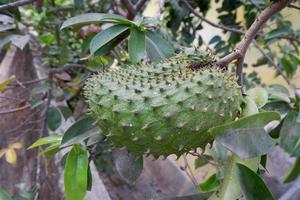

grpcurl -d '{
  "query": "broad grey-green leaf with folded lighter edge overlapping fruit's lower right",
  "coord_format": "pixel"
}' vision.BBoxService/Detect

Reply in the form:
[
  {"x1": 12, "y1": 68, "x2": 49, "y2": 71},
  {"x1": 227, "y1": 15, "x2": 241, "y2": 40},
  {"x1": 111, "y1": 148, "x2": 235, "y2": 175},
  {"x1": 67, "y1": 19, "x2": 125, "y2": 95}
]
[{"x1": 210, "y1": 112, "x2": 280, "y2": 158}]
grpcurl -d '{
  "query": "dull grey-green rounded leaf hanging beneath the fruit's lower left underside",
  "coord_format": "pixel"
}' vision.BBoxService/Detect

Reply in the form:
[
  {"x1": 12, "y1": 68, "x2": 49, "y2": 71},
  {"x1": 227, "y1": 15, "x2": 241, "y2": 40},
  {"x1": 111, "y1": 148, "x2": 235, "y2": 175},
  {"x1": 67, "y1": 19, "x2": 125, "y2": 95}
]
[{"x1": 113, "y1": 150, "x2": 143, "y2": 184}]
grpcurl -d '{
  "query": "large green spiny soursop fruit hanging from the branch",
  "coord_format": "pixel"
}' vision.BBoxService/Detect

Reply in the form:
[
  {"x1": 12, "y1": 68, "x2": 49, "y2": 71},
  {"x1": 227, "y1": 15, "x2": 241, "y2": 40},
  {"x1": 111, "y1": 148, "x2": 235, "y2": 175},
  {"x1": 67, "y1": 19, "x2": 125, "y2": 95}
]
[{"x1": 84, "y1": 54, "x2": 242, "y2": 158}]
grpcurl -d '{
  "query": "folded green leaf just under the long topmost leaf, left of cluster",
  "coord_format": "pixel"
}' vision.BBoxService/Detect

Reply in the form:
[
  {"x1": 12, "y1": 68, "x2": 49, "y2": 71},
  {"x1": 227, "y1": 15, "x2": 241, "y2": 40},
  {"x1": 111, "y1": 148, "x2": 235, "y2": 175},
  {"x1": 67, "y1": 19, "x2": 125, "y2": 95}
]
[{"x1": 90, "y1": 25, "x2": 129, "y2": 54}]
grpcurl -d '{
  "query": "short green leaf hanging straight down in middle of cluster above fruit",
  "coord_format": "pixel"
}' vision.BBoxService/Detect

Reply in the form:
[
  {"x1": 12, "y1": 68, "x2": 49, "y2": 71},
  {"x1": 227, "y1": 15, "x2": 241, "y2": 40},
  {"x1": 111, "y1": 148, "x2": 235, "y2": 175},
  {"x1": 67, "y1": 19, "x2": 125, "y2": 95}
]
[{"x1": 128, "y1": 28, "x2": 146, "y2": 64}]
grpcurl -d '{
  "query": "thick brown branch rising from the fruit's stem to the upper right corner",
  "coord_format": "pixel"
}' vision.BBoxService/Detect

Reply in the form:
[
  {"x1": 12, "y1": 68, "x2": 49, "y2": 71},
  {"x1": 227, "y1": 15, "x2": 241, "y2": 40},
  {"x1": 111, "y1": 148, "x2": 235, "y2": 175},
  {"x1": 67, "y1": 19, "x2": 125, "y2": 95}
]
[{"x1": 216, "y1": 0, "x2": 291, "y2": 66}]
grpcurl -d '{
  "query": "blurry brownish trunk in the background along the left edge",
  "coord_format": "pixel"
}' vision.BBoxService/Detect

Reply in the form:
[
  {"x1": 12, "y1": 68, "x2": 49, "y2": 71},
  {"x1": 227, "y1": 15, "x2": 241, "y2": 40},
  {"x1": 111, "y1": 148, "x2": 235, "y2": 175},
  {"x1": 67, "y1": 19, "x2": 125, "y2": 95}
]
[{"x1": 0, "y1": 47, "x2": 61, "y2": 200}]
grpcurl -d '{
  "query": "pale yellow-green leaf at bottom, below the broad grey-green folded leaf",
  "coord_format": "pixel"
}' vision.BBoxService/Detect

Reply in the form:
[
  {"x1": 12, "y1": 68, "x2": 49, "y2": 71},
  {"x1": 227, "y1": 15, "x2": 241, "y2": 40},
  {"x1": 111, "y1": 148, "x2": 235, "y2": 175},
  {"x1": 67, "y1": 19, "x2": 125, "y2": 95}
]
[{"x1": 209, "y1": 155, "x2": 260, "y2": 200}]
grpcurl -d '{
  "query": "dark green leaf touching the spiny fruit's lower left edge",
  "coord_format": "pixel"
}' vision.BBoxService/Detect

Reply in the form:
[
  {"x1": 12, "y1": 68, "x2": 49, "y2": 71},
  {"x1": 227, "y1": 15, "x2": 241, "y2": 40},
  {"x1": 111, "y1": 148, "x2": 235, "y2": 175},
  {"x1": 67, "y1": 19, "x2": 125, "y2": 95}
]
[{"x1": 61, "y1": 117, "x2": 100, "y2": 147}]
